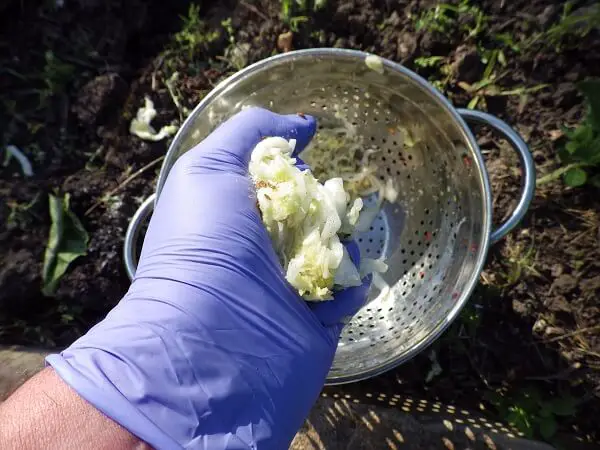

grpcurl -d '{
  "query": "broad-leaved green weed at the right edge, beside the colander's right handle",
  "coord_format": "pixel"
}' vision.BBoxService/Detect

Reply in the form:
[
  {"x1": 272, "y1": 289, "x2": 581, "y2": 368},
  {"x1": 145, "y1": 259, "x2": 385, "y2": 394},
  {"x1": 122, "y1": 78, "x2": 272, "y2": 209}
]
[{"x1": 537, "y1": 79, "x2": 600, "y2": 187}]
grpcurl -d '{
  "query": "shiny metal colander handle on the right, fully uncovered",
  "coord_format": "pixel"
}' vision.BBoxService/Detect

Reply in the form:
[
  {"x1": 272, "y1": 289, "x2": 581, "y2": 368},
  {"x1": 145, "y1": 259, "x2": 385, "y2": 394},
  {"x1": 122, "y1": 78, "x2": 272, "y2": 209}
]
[{"x1": 458, "y1": 109, "x2": 535, "y2": 243}]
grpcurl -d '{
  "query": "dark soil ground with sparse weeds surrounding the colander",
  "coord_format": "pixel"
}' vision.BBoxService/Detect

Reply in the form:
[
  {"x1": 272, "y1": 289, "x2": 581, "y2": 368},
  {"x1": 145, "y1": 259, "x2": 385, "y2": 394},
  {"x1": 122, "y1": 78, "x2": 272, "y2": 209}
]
[{"x1": 0, "y1": 0, "x2": 600, "y2": 441}]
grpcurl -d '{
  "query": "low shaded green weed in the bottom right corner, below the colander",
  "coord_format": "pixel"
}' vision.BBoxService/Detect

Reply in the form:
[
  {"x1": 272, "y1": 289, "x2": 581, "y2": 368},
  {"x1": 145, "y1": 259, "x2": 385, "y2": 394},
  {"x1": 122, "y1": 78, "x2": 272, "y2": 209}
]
[{"x1": 486, "y1": 386, "x2": 577, "y2": 441}]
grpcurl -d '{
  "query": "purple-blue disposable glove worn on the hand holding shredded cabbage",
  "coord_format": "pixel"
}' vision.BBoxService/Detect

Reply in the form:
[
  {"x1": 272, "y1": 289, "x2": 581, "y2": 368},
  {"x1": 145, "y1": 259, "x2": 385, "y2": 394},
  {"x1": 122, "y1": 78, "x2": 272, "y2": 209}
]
[{"x1": 47, "y1": 108, "x2": 368, "y2": 450}]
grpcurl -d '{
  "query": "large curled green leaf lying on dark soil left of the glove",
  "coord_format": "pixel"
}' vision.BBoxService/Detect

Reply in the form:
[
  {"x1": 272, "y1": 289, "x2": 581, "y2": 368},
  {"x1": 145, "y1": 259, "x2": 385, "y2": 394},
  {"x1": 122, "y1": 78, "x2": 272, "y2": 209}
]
[{"x1": 42, "y1": 194, "x2": 89, "y2": 296}]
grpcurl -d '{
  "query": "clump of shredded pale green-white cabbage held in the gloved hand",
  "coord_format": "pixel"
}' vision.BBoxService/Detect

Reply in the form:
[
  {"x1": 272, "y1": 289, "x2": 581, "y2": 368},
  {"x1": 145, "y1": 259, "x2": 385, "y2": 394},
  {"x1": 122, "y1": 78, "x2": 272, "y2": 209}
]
[{"x1": 250, "y1": 137, "x2": 385, "y2": 301}]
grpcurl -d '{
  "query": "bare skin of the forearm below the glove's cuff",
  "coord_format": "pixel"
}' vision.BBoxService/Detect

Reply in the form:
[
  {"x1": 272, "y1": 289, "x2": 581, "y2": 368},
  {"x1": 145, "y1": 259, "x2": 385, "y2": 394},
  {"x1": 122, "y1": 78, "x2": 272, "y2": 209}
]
[{"x1": 0, "y1": 368, "x2": 150, "y2": 450}]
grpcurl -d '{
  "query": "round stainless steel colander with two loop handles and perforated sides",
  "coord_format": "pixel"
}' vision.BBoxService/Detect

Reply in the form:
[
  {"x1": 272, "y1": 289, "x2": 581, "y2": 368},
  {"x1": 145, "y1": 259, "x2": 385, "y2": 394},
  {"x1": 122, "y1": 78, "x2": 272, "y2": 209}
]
[{"x1": 124, "y1": 49, "x2": 535, "y2": 384}]
